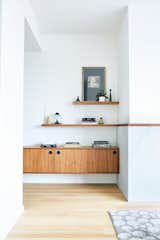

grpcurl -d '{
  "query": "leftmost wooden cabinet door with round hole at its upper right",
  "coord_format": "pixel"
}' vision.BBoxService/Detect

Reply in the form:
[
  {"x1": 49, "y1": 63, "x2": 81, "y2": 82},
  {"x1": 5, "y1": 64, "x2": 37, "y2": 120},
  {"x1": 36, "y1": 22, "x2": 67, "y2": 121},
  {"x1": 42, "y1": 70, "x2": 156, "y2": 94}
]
[{"x1": 23, "y1": 149, "x2": 54, "y2": 173}]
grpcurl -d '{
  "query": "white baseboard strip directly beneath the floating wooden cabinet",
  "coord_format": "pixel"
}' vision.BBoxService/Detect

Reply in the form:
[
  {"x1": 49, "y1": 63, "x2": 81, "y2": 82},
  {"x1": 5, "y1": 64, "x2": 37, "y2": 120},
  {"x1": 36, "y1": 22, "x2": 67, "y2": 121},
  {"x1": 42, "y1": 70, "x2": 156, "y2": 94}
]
[{"x1": 23, "y1": 174, "x2": 117, "y2": 184}]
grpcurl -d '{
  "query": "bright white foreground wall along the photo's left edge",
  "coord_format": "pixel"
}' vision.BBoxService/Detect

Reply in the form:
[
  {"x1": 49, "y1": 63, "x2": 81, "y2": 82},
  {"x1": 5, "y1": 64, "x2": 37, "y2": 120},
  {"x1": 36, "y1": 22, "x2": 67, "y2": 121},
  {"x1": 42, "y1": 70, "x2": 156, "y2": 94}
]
[{"x1": 0, "y1": 0, "x2": 24, "y2": 237}]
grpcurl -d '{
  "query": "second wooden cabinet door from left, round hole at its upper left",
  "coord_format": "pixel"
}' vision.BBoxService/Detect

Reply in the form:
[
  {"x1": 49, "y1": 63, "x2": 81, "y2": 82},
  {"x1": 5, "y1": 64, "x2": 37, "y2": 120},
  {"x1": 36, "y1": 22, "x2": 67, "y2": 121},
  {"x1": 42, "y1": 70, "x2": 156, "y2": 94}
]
[{"x1": 55, "y1": 149, "x2": 87, "y2": 173}]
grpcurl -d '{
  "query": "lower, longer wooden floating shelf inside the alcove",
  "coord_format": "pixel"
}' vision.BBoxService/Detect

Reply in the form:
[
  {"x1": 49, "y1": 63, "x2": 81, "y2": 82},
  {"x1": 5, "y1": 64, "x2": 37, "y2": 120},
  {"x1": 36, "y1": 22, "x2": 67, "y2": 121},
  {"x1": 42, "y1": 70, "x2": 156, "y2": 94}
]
[{"x1": 41, "y1": 123, "x2": 119, "y2": 127}]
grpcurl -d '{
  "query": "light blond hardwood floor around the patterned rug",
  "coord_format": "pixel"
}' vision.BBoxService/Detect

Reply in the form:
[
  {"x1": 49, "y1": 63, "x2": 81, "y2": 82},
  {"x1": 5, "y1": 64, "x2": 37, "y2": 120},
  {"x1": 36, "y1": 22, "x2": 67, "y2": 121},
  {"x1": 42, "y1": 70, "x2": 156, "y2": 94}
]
[{"x1": 7, "y1": 184, "x2": 160, "y2": 240}]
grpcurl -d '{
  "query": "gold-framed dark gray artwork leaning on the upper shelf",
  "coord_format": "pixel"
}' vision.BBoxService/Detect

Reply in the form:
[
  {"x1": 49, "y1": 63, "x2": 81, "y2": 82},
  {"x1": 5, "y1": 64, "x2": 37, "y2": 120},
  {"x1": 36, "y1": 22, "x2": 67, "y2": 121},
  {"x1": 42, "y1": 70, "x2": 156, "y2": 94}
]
[{"x1": 82, "y1": 67, "x2": 106, "y2": 101}]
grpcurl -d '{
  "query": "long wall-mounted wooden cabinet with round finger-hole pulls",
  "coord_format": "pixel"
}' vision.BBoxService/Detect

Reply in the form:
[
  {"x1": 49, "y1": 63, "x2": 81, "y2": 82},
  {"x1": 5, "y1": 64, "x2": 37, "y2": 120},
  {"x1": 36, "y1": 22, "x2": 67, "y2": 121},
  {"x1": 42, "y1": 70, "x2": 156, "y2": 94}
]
[{"x1": 23, "y1": 147, "x2": 119, "y2": 174}]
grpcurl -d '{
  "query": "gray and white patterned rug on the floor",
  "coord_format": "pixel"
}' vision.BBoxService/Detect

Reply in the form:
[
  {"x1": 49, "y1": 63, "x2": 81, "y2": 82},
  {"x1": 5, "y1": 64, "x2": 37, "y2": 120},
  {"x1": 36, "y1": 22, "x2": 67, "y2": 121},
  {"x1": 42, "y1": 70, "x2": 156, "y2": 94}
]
[{"x1": 109, "y1": 210, "x2": 160, "y2": 240}]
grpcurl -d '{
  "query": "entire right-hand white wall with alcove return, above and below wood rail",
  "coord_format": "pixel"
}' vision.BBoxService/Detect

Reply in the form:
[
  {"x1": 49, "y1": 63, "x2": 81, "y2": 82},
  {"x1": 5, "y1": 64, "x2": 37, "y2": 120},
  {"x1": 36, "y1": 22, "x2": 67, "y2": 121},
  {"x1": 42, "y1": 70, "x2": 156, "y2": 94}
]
[{"x1": 118, "y1": 0, "x2": 160, "y2": 201}]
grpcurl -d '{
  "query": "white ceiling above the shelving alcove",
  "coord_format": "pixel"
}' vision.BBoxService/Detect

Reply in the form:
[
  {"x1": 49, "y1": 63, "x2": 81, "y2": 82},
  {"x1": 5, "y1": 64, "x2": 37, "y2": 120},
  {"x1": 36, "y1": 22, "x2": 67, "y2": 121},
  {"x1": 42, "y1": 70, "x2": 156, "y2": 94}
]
[{"x1": 29, "y1": 0, "x2": 129, "y2": 34}]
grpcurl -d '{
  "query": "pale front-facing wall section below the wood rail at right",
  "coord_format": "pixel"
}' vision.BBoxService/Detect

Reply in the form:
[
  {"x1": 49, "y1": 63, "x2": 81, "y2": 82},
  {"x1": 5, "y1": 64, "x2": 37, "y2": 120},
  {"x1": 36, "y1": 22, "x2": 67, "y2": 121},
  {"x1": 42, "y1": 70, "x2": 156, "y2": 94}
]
[{"x1": 128, "y1": 127, "x2": 160, "y2": 202}]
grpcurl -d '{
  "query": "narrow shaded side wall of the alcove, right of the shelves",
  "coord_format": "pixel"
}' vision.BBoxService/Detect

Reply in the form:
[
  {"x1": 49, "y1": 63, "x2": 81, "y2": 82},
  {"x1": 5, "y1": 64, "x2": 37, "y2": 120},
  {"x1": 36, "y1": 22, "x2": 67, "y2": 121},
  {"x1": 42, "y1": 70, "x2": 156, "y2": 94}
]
[{"x1": 118, "y1": 9, "x2": 129, "y2": 198}]
